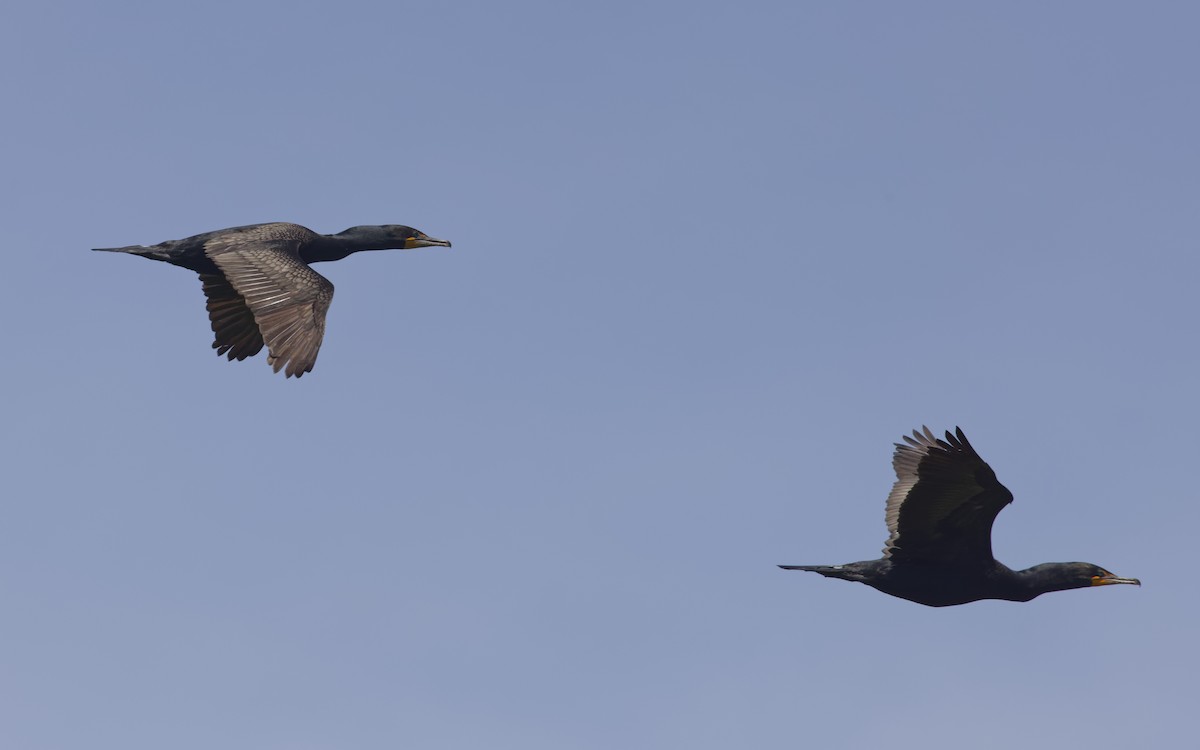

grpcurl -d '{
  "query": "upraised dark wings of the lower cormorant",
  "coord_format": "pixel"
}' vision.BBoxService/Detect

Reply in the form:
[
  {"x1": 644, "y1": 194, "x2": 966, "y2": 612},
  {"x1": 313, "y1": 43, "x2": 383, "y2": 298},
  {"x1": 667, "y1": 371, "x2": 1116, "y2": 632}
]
[{"x1": 883, "y1": 427, "x2": 1013, "y2": 563}]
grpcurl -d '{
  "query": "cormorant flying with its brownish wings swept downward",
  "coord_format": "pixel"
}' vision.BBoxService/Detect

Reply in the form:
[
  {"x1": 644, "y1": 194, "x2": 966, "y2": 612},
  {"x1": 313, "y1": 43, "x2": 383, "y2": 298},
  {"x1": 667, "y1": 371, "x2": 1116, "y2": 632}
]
[{"x1": 96, "y1": 222, "x2": 450, "y2": 378}]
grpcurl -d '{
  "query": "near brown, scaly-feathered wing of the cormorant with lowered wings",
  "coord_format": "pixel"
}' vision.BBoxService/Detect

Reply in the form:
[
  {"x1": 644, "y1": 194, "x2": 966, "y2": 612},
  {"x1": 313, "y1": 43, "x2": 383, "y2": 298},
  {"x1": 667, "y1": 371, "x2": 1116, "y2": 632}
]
[{"x1": 204, "y1": 236, "x2": 334, "y2": 378}]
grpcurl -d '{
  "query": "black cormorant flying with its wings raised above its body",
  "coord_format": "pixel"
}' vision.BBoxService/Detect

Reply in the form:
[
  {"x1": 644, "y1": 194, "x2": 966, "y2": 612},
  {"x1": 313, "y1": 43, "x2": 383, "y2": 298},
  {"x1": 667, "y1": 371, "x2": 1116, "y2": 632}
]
[{"x1": 780, "y1": 427, "x2": 1141, "y2": 607}]
